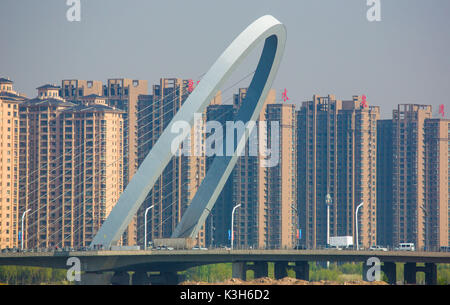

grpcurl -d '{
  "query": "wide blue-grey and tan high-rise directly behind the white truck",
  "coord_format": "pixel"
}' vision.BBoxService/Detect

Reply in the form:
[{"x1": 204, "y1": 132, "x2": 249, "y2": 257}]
[{"x1": 297, "y1": 95, "x2": 379, "y2": 248}]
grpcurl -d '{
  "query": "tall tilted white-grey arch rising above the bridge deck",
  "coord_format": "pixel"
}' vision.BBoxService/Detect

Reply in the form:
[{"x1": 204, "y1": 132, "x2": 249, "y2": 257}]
[{"x1": 91, "y1": 15, "x2": 286, "y2": 248}]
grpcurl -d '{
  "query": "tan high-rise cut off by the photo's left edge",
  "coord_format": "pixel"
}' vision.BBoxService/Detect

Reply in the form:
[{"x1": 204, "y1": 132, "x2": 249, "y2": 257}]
[{"x1": 0, "y1": 78, "x2": 26, "y2": 249}]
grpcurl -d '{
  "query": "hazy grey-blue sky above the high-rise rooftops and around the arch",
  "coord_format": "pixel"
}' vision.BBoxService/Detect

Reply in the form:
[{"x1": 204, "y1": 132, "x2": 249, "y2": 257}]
[{"x1": 0, "y1": 0, "x2": 450, "y2": 117}]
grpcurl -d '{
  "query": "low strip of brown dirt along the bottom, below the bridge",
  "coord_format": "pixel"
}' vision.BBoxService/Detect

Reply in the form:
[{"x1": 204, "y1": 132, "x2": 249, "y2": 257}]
[{"x1": 181, "y1": 277, "x2": 388, "y2": 285}]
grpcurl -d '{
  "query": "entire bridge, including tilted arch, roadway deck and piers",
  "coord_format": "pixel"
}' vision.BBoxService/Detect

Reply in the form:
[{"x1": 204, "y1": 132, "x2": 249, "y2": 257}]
[{"x1": 9, "y1": 16, "x2": 450, "y2": 284}]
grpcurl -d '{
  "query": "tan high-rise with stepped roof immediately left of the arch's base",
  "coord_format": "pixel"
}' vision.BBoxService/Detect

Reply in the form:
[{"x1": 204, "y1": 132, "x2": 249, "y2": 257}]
[{"x1": 61, "y1": 95, "x2": 124, "y2": 246}]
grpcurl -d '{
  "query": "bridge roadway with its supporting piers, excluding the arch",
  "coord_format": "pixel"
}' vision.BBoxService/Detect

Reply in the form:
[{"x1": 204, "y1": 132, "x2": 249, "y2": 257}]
[{"x1": 0, "y1": 249, "x2": 450, "y2": 285}]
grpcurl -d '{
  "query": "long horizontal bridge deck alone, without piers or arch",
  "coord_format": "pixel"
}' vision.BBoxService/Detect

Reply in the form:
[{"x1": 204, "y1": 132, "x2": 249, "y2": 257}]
[{"x1": 0, "y1": 249, "x2": 450, "y2": 272}]
